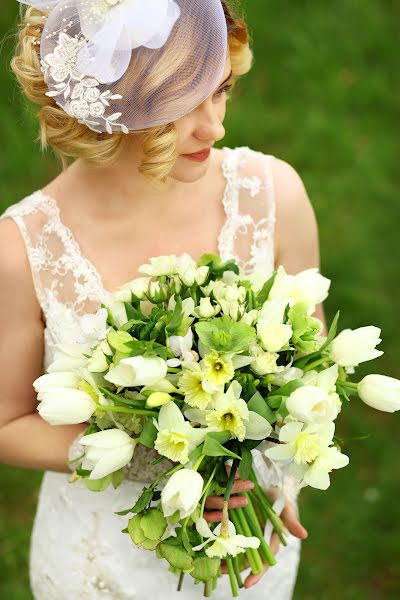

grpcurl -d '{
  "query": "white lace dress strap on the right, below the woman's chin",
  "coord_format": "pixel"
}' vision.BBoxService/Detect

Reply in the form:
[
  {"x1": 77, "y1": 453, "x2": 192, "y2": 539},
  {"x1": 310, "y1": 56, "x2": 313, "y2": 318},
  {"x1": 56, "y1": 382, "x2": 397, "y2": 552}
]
[{"x1": 219, "y1": 146, "x2": 275, "y2": 277}]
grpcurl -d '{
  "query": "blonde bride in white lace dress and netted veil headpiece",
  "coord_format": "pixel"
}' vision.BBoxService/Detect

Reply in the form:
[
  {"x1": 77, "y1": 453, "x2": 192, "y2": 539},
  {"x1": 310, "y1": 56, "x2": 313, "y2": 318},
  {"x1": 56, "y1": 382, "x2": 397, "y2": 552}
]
[{"x1": 0, "y1": 0, "x2": 323, "y2": 600}]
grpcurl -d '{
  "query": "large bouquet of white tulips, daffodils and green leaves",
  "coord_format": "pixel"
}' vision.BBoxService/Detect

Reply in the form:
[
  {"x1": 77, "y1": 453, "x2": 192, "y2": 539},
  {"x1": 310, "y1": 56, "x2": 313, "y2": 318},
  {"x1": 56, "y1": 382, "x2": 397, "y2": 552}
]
[{"x1": 34, "y1": 254, "x2": 400, "y2": 596}]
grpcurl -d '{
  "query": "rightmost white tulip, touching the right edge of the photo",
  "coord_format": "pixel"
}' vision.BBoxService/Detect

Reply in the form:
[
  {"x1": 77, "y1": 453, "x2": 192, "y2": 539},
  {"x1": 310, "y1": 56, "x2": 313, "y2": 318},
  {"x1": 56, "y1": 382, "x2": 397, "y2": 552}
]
[{"x1": 358, "y1": 374, "x2": 400, "y2": 412}]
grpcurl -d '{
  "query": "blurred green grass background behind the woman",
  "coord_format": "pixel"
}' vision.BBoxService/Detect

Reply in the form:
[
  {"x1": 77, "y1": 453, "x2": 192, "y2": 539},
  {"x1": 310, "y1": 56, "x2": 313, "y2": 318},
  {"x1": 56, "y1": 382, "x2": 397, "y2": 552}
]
[{"x1": 0, "y1": 0, "x2": 400, "y2": 600}]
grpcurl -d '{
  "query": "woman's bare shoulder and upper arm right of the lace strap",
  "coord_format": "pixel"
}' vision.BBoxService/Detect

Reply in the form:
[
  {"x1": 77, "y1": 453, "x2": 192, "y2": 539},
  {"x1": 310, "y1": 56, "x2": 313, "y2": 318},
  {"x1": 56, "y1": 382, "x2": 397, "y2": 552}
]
[{"x1": 272, "y1": 158, "x2": 319, "y2": 272}]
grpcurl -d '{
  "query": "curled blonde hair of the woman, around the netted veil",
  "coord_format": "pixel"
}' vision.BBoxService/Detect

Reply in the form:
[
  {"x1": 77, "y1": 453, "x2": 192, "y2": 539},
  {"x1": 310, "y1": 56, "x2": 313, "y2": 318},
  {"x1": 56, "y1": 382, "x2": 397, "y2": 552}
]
[{"x1": 11, "y1": 0, "x2": 253, "y2": 186}]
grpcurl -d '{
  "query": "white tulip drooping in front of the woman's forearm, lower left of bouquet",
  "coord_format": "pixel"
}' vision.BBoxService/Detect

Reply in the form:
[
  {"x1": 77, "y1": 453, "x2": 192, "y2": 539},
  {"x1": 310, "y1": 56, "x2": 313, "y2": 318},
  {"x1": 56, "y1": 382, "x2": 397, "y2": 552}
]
[{"x1": 80, "y1": 429, "x2": 136, "y2": 479}]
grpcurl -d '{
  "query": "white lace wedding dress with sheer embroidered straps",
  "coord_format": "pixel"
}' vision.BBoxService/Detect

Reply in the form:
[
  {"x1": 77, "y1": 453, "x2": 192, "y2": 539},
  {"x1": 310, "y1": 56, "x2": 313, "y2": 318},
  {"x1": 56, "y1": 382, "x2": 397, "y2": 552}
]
[{"x1": 2, "y1": 147, "x2": 300, "y2": 600}]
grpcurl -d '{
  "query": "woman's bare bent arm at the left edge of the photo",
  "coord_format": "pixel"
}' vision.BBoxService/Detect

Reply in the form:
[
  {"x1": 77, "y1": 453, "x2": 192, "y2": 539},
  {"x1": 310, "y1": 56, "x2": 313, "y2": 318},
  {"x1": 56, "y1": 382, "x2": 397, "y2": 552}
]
[{"x1": 0, "y1": 219, "x2": 86, "y2": 472}]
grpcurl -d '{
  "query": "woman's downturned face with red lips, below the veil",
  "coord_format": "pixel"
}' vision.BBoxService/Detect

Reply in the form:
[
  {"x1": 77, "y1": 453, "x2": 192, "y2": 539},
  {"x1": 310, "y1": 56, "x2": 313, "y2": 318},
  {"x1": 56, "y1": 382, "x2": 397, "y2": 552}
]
[{"x1": 171, "y1": 57, "x2": 232, "y2": 183}]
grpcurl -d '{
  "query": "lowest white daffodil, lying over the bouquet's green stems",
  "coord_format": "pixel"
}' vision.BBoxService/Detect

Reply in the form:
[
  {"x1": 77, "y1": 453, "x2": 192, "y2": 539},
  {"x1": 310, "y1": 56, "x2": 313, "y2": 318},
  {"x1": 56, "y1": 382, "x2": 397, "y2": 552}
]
[{"x1": 192, "y1": 517, "x2": 260, "y2": 558}]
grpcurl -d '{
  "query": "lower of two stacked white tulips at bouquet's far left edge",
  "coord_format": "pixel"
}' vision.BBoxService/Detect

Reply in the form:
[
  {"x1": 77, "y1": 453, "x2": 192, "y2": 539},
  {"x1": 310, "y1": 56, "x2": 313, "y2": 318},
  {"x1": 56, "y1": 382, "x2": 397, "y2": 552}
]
[{"x1": 37, "y1": 388, "x2": 96, "y2": 425}]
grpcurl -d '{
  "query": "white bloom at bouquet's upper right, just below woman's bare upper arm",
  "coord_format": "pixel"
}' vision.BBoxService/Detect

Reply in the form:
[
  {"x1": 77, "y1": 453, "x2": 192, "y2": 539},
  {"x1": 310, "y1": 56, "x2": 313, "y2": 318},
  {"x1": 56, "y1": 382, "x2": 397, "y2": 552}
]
[{"x1": 269, "y1": 267, "x2": 331, "y2": 314}]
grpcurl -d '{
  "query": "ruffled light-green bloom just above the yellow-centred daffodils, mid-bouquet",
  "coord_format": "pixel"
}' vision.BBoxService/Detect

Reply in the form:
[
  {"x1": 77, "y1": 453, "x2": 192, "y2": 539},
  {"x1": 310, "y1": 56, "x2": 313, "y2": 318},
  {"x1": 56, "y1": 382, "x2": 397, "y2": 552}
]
[{"x1": 194, "y1": 315, "x2": 255, "y2": 354}]
